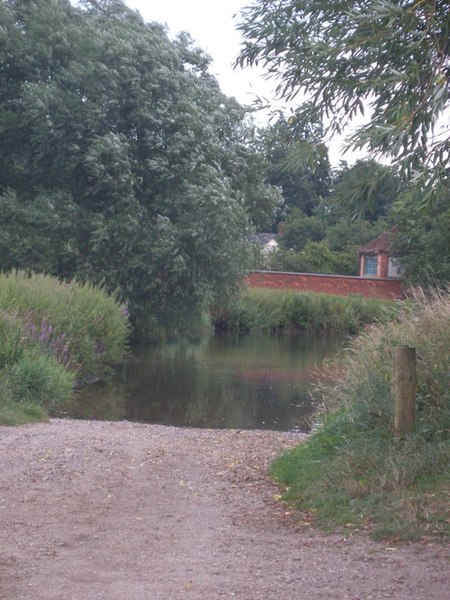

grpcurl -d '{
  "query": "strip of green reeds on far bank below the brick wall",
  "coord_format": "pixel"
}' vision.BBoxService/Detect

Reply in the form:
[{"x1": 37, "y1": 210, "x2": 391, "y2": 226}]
[{"x1": 215, "y1": 288, "x2": 398, "y2": 334}]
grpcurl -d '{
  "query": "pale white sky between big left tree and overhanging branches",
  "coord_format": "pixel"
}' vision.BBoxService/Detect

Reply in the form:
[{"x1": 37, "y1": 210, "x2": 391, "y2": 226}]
[{"x1": 125, "y1": 0, "x2": 357, "y2": 165}]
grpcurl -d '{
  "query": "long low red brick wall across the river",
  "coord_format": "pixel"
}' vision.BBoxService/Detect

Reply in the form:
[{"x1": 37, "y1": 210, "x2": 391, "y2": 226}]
[{"x1": 245, "y1": 271, "x2": 404, "y2": 300}]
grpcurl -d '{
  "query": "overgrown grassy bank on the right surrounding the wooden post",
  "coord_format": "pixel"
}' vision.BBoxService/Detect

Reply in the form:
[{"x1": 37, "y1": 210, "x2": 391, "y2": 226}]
[{"x1": 272, "y1": 292, "x2": 450, "y2": 539}]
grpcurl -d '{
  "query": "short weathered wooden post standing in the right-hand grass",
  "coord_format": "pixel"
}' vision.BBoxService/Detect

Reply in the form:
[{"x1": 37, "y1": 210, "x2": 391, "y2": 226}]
[{"x1": 394, "y1": 346, "x2": 416, "y2": 437}]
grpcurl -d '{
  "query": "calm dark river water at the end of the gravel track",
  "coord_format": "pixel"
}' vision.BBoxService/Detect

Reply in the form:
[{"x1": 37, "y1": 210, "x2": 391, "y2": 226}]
[{"x1": 71, "y1": 334, "x2": 342, "y2": 431}]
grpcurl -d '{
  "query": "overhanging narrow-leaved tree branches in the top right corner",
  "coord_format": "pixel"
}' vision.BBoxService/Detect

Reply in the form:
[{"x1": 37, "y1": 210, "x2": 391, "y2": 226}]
[{"x1": 238, "y1": 0, "x2": 450, "y2": 189}]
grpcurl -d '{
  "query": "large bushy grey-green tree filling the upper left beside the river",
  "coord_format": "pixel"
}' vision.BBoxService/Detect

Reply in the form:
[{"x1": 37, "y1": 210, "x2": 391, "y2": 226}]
[{"x1": 0, "y1": 0, "x2": 276, "y2": 336}]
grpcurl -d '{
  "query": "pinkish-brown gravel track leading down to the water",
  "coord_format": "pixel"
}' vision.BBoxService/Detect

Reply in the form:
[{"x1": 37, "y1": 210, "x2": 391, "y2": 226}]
[{"x1": 0, "y1": 420, "x2": 450, "y2": 600}]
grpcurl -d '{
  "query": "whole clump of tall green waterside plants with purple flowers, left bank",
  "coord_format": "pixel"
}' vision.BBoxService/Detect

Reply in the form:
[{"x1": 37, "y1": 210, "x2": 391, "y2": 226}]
[{"x1": 0, "y1": 272, "x2": 128, "y2": 424}]
